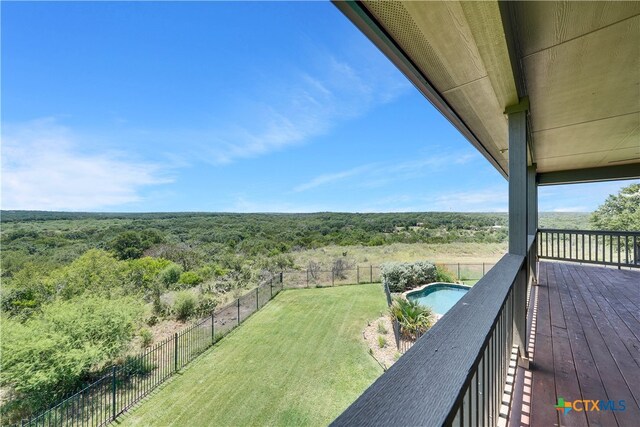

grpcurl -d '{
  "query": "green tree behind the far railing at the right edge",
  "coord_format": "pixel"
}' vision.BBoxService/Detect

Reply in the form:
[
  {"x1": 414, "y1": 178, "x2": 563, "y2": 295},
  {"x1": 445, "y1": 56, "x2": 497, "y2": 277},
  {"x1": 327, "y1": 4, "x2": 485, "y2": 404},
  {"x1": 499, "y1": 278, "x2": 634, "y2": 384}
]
[{"x1": 591, "y1": 184, "x2": 640, "y2": 231}]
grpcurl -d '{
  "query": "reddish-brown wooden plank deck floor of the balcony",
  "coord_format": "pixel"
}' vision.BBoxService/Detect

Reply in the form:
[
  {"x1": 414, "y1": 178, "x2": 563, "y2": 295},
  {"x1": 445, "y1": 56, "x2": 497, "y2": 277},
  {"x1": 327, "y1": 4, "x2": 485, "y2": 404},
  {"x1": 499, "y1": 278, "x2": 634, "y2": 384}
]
[{"x1": 509, "y1": 262, "x2": 640, "y2": 427}]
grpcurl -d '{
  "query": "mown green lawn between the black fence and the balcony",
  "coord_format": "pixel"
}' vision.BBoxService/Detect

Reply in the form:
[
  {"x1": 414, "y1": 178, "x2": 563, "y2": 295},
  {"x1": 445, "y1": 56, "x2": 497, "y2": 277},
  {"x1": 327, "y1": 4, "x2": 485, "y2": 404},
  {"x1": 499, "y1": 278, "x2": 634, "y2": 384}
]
[{"x1": 119, "y1": 285, "x2": 386, "y2": 426}]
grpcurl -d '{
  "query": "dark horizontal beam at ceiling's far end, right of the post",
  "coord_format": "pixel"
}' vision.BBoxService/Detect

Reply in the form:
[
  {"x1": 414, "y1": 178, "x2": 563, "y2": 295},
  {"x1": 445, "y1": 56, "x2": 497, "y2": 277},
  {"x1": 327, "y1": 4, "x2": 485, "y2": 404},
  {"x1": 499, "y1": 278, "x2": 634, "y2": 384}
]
[{"x1": 536, "y1": 163, "x2": 640, "y2": 185}]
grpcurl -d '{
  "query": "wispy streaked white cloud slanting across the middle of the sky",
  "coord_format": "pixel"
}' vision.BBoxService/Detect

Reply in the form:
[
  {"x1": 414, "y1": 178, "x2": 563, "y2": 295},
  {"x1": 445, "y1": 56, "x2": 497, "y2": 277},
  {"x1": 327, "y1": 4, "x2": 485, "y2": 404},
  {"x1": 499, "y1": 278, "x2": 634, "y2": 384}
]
[{"x1": 200, "y1": 55, "x2": 409, "y2": 164}]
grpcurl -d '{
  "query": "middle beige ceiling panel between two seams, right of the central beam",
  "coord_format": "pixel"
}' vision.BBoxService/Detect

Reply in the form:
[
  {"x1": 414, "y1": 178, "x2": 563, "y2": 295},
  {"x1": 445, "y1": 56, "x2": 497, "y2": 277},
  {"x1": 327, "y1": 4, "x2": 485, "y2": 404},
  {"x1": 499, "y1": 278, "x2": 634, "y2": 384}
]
[{"x1": 523, "y1": 16, "x2": 640, "y2": 131}]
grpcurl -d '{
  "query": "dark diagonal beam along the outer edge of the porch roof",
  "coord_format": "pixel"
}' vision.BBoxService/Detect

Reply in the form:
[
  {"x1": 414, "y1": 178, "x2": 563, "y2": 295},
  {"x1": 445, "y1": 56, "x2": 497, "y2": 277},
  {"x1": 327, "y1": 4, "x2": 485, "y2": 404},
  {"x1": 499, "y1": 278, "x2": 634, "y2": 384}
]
[{"x1": 332, "y1": 0, "x2": 508, "y2": 178}]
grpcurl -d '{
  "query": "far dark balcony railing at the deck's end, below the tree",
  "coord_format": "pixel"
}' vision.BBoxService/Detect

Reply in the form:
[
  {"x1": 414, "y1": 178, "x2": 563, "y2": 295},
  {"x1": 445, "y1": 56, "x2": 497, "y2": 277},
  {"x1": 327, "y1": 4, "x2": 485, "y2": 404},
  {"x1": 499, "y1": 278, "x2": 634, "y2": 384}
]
[{"x1": 538, "y1": 228, "x2": 640, "y2": 268}]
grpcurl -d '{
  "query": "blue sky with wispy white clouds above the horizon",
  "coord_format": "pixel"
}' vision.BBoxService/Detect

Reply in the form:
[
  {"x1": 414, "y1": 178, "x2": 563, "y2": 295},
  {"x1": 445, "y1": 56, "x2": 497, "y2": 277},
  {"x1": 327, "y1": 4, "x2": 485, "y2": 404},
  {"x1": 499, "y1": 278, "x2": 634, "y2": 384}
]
[{"x1": 2, "y1": 2, "x2": 628, "y2": 212}]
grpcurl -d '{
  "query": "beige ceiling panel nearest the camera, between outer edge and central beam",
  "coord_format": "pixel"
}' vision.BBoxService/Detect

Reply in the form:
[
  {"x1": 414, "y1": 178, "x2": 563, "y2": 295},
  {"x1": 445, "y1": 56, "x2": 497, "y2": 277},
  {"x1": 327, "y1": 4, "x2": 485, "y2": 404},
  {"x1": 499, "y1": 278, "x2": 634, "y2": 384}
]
[{"x1": 365, "y1": 1, "x2": 486, "y2": 92}]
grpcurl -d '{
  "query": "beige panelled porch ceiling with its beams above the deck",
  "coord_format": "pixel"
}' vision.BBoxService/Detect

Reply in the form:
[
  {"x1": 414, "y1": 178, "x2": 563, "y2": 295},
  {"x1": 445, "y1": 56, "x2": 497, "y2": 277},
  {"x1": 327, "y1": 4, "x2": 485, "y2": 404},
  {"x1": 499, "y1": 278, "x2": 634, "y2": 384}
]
[{"x1": 336, "y1": 1, "x2": 640, "y2": 183}]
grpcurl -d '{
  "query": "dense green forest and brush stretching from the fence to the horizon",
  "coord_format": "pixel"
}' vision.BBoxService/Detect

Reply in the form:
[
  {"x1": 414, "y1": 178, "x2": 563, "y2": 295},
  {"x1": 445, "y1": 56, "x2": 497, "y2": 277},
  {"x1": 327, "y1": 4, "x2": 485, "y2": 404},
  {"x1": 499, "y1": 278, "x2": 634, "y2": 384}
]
[{"x1": 0, "y1": 211, "x2": 589, "y2": 419}]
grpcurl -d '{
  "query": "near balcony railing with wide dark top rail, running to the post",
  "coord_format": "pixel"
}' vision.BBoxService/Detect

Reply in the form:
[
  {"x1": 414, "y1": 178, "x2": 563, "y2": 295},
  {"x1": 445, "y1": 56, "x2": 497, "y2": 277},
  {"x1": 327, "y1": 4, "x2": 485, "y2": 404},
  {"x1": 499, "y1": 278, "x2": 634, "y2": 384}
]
[{"x1": 333, "y1": 236, "x2": 537, "y2": 426}]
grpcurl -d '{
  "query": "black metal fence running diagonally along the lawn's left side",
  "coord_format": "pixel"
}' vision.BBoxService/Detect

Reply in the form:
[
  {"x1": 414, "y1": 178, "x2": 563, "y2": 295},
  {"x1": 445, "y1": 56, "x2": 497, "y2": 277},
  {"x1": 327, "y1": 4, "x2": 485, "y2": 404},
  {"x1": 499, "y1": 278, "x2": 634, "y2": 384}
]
[{"x1": 20, "y1": 274, "x2": 283, "y2": 427}]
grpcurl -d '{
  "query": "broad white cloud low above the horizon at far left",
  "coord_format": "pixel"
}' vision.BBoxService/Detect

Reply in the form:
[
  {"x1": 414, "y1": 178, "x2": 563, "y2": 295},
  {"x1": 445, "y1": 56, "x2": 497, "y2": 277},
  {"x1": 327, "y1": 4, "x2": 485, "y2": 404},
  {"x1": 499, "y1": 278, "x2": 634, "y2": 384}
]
[{"x1": 2, "y1": 119, "x2": 171, "y2": 210}]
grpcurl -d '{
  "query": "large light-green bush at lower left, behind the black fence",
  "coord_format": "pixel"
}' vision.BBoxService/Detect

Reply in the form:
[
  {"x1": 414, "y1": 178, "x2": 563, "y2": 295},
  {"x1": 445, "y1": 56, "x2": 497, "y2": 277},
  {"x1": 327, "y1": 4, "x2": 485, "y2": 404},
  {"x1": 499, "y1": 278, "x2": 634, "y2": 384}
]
[{"x1": 0, "y1": 296, "x2": 142, "y2": 418}]
